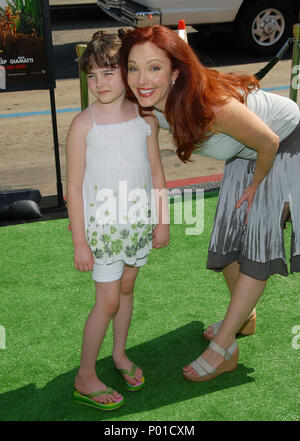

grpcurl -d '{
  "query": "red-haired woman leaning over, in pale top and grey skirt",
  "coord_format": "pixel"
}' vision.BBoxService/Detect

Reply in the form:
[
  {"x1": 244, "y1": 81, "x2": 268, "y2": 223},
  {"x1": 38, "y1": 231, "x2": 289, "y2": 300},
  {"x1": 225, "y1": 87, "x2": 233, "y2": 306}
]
[{"x1": 120, "y1": 25, "x2": 300, "y2": 381}]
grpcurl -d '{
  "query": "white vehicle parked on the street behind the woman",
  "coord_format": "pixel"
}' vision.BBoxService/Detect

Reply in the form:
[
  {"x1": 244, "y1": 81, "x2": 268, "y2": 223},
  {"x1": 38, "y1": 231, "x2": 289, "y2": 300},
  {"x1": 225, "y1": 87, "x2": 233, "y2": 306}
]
[{"x1": 97, "y1": 0, "x2": 299, "y2": 55}]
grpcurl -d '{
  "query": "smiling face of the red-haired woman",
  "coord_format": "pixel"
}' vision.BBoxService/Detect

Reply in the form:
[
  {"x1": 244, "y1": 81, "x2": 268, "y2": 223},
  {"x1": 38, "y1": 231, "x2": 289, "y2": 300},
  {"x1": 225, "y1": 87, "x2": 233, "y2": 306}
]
[{"x1": 127, "y1": 42, "x2": 178, "y2": 112}]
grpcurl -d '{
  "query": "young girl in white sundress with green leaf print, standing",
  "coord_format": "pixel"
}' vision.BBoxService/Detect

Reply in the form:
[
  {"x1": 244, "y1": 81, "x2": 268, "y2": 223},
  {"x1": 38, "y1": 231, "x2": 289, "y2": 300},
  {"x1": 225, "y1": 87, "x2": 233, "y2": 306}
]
[{"x1": 67, "y1": 32, "x2": 169, "y2": 410}]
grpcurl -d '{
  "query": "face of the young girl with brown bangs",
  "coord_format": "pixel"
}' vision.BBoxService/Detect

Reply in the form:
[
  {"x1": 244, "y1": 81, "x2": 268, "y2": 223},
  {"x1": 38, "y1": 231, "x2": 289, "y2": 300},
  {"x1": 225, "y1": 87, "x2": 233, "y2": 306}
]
[{"x1": 87, "y1": 66, "x2": 125, "y2": 104}]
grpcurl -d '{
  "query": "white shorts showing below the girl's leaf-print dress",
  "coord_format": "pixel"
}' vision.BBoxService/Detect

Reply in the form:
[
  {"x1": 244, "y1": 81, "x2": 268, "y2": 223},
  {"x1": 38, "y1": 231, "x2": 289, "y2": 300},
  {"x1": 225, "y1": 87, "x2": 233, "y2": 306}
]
[{"x1": 92, "y1": 255, "x2": 148, "y2": 282}]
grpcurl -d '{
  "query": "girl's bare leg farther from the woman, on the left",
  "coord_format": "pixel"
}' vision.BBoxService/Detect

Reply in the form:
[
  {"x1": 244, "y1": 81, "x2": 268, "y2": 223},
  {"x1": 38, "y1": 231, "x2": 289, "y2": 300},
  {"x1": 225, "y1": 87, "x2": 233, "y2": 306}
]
[{"x1": 75, "y1": 280, "x2": 121, "y2": 403}]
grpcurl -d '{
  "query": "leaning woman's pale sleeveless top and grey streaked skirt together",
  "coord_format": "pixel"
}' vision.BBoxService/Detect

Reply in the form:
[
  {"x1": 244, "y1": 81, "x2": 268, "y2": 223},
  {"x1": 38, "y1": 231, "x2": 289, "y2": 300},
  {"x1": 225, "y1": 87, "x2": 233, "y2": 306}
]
[{"x1": 155, "y1": 90, "x2": 300, "y2": 280}]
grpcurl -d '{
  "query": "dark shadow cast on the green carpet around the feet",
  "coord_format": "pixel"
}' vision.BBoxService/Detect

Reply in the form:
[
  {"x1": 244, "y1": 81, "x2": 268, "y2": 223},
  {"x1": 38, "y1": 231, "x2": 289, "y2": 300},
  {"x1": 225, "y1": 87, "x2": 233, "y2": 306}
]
[{"x1": 0, "y1": 321, "x2": 254, "y2": 421}]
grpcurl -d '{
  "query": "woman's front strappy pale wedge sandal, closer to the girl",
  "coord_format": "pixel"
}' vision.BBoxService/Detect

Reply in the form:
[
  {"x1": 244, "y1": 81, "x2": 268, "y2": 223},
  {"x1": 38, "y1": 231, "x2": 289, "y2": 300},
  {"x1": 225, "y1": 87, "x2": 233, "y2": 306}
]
[{"x1": 183, "y1": 341, "x2": 239, "y2": 381}]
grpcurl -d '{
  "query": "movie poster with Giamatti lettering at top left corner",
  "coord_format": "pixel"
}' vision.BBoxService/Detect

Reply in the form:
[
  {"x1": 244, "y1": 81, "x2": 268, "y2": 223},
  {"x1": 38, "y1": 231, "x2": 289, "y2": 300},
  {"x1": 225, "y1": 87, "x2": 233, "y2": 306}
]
[{"x1": 0, "y1": 0, "x2": 53, "y2": 92}]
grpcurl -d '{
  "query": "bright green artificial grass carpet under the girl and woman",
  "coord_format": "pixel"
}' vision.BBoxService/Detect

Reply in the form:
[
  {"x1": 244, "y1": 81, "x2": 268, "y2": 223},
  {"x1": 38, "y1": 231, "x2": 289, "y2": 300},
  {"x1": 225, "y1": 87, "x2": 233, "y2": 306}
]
[{"x1": 0, "y1": 198, "x2": 300, "y2": 421}]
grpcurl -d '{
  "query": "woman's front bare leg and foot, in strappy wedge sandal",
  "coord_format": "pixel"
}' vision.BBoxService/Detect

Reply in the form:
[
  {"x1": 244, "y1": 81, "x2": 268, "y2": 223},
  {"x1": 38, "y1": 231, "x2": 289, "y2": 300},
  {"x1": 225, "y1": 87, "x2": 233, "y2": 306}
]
[{"x1": 183, "y1": 273, "x2": 267, "y2": 375}]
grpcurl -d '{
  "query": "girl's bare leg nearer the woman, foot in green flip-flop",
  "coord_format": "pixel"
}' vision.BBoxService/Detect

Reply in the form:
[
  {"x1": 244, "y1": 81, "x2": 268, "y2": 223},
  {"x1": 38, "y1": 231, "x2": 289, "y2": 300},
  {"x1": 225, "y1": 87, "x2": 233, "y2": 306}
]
[{"x1": 112, "y1": 265, "x2": 143, "y2": 385}]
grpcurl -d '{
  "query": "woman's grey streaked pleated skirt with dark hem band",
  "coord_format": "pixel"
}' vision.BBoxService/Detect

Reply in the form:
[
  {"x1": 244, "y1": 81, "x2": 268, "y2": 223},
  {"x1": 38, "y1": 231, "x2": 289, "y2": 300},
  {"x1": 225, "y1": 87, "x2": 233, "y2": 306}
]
[{"x1": 207, "y1": 124, "x2": 300, "y2": 280}]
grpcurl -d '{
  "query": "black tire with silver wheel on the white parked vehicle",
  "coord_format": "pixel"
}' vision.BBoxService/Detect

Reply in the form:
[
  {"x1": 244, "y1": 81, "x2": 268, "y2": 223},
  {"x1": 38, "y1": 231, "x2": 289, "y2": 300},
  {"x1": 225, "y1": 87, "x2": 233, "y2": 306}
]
[{"x1": 236, "y1": 0, "x2": 295, "y2": 55}]
